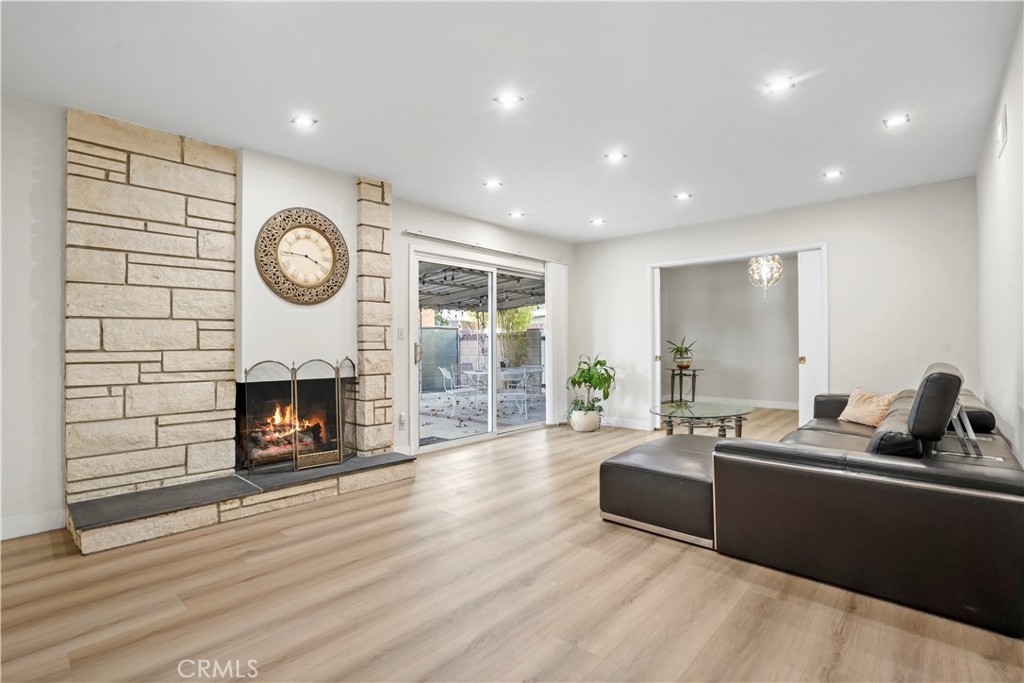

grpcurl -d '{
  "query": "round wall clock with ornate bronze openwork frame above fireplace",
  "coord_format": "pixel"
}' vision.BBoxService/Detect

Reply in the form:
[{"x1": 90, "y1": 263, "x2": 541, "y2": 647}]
[{"x1": 256, "y1": 208, "x2": 348, "y2": 304}]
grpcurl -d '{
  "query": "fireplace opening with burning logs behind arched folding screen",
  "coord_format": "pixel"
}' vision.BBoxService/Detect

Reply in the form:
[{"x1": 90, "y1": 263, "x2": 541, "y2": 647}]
[{"x1": 236, "y1": 357, "x2": 357, "y2": 472}]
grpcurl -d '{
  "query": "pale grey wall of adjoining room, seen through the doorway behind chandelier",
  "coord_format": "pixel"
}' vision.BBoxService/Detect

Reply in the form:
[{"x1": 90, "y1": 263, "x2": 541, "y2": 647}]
[{"x1": 659, "y1": 255, "x2": 800, "y2": 410}]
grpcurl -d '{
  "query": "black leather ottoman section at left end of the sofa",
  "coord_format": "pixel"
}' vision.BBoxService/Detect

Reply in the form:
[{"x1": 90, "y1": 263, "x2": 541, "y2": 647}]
[{"x1": 600, "y1": 434, "x2": 721, "y2": 548}]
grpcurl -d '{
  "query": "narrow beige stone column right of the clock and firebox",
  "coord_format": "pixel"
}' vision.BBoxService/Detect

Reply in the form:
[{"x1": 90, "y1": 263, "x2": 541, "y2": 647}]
[{"x1": 354, "y1": 177, "x2": 394, "y2": 456}]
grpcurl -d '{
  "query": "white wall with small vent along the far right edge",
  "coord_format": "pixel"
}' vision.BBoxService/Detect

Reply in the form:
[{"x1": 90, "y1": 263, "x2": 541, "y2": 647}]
[{"x1": 978, "y1": 15, "x2": 1024, "y2": 458}]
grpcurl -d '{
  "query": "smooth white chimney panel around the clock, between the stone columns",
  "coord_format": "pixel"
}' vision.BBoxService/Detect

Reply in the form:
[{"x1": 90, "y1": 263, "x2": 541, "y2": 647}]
[{"x1": 236, "y1": 150, "x2": 357, "y2": 381}]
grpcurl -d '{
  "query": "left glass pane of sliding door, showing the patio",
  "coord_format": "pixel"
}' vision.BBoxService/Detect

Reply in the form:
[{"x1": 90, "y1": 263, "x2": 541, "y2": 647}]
[{"x1": 416, "y1": 260, "x2": 495, "y2": 446}]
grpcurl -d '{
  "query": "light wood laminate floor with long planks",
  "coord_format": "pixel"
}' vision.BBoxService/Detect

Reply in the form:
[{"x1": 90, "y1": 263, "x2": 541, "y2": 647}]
[{"x1": 0, "y1": 411, "x2": 1024, "y2": 682}]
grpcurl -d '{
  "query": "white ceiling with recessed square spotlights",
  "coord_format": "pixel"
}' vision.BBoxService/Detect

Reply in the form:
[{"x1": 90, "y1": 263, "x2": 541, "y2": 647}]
[{"x1": 0, "y1": 2, "x2": 1022, "y2": 242}]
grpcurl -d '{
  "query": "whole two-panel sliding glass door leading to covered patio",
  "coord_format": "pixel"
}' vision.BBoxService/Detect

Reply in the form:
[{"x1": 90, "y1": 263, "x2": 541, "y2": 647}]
[{"x1": 413, "y1": 256, "x2": 546, "y2": 446}]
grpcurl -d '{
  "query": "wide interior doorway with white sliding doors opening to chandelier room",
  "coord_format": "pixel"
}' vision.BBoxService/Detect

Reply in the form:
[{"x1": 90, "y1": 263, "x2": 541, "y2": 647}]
[{"x1": 650, "y1": 245, "x2": 828, "y2": 428}]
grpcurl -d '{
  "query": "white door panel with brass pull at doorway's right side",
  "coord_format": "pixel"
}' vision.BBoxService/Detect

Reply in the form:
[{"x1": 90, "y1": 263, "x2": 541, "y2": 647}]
[{"x1": 794, "y1": 249, "x2": 828, "y2": 424}]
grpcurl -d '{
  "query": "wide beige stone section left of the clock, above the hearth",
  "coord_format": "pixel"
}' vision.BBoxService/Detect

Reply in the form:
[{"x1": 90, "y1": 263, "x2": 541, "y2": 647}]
[{"x1": 65, "y1": 110, "x2": 237, "y2": 503}]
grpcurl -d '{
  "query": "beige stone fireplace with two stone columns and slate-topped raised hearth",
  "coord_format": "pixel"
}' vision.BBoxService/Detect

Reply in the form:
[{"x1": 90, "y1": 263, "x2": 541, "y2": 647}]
[{"x1": 65, "y1": 110, "x2": 414, "y2": 553}]
